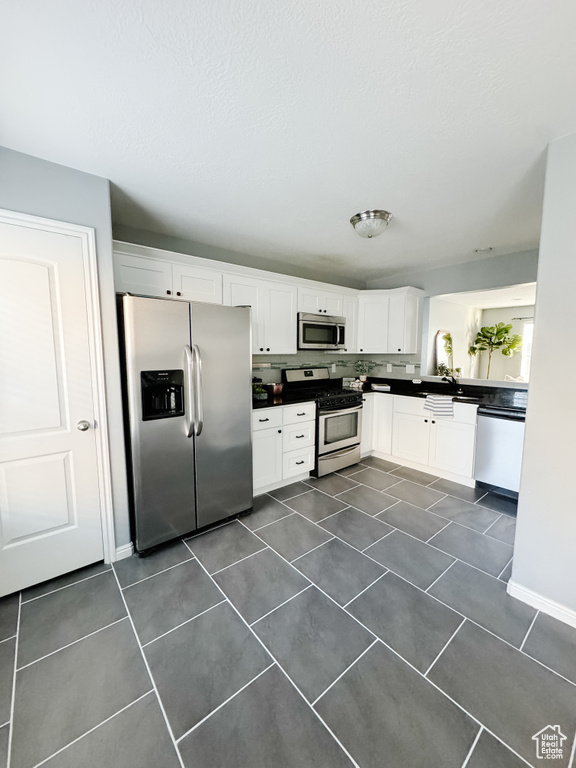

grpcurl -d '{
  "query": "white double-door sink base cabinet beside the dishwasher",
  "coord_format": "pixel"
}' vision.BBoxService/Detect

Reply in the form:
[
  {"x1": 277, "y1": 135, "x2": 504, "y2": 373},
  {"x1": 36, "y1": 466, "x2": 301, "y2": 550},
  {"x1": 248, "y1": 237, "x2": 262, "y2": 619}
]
[{"x1": 391, "y1": 396, "x2": 477, "y2": 478}]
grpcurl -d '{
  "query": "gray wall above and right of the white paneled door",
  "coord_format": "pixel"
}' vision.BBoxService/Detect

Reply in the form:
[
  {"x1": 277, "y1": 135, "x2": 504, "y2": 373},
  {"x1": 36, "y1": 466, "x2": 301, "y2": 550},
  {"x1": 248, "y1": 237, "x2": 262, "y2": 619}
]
[{"x1": 0, "y1": 147, "x2": 130, "y2": 547}]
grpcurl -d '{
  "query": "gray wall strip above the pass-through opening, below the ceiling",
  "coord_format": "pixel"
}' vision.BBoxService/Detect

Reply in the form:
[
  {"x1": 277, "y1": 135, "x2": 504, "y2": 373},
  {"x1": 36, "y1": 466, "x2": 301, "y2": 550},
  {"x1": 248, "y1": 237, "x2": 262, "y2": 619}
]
[{"x1": 367, "y1": 250, "x2": 538, "y2": 296}]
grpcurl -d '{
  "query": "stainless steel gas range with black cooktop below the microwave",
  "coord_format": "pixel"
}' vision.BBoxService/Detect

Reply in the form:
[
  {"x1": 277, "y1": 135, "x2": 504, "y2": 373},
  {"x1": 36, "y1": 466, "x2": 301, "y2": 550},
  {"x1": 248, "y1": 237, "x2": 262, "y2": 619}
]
[{"x1": 282, "y1": 368, "x2": 362, "y2": 477}]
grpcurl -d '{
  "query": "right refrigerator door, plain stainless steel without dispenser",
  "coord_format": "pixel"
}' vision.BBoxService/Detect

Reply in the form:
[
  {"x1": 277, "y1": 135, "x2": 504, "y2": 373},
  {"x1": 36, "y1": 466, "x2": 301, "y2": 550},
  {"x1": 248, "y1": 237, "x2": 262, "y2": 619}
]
[{"x1": 191, "y1": 302, "x2": 252, "y2": 528}]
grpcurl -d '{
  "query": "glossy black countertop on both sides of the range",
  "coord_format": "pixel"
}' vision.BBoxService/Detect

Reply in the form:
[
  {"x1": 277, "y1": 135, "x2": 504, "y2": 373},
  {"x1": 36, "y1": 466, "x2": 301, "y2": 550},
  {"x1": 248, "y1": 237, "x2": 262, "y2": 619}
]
[{"x1": 252, "y1": 376, "x2": 528, "y2": 412}]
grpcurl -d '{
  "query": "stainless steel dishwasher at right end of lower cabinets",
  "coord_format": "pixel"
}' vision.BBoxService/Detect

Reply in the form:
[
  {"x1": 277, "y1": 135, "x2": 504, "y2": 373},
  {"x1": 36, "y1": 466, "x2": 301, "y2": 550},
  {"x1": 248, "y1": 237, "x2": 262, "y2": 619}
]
[{"x1": 474, "y1": 405, "x2": 526, "y2": 492}]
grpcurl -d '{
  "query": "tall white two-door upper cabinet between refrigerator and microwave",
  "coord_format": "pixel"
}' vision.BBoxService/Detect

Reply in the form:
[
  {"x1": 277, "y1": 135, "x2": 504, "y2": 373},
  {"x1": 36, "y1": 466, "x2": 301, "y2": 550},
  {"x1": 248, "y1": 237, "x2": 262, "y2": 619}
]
[{"x1": 223, "y1": 274, "x2": 297, "y2": 355}]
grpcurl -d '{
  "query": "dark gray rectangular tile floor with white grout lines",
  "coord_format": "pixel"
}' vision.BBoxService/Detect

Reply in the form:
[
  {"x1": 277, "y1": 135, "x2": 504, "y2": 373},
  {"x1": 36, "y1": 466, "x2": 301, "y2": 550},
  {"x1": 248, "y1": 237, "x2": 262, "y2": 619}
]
[{"x1": 0, "y1": 458, "x2": 576, "y2": 768}]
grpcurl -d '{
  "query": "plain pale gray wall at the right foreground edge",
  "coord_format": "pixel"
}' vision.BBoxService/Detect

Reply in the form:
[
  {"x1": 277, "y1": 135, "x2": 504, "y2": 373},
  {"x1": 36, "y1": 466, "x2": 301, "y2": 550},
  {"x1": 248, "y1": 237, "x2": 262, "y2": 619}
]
[{"x1": 510, "y1": 134, "x2": 576, "y2": 625}]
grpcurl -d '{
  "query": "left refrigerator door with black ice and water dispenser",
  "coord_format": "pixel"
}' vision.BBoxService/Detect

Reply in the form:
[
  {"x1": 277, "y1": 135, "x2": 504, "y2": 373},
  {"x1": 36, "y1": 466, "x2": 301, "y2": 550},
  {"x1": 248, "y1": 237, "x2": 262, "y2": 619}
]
[{"x1": 123, "y1": 296, "x2": 196, "y2": 552}]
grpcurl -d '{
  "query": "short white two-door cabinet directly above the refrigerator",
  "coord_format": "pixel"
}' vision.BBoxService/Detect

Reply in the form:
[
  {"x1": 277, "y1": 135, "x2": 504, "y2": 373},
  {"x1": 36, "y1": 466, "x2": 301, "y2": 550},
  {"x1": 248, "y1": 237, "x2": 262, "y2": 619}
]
[{"x1": 114, "y1": 253, "x2": 222, "y2": 304}]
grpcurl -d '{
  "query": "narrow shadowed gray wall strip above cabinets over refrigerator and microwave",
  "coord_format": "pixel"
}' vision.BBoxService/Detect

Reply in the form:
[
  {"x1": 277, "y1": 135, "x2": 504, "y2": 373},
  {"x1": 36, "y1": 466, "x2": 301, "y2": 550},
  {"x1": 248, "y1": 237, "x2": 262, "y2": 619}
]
[{"x1": 114, "y1": 224, "x2": 364, "y2": 289}]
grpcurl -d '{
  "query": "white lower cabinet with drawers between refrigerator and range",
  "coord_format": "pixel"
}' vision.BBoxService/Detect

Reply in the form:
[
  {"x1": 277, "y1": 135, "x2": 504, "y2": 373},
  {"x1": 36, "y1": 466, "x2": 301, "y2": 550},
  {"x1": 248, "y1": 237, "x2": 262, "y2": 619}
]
[{"x1": 252, "y1": 403, "x2": 316, "y2": 493}]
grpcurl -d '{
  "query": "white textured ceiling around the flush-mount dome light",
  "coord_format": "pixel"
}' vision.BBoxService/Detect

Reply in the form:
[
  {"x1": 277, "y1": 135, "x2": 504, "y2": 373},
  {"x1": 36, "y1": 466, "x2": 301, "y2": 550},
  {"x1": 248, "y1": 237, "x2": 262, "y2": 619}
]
[{"x1": 0, "y1": 0, "x2": 576, "y2": 280}]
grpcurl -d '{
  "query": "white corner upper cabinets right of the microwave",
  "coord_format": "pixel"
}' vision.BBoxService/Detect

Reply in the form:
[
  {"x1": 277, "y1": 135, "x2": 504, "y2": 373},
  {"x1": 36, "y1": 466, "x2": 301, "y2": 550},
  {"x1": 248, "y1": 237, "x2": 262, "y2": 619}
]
[{"x1": 357, "y1": 288, "x2": 424, "y2": 355}]
